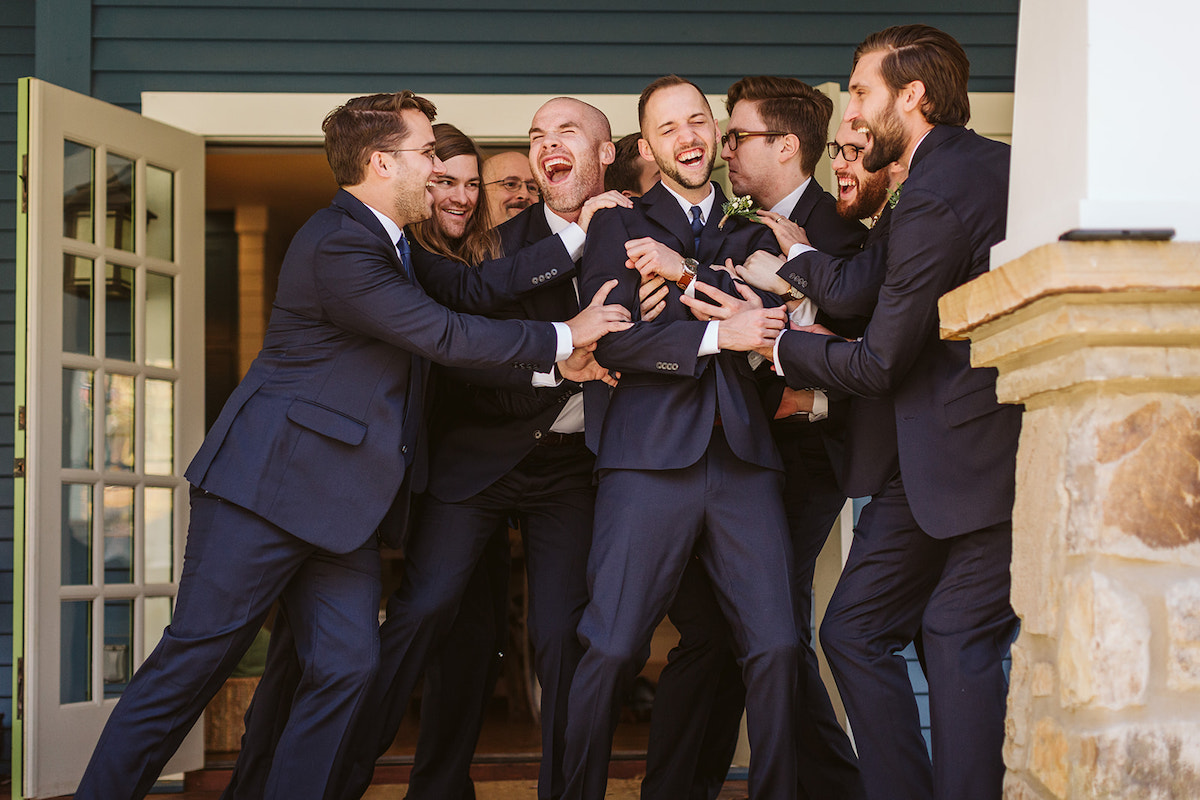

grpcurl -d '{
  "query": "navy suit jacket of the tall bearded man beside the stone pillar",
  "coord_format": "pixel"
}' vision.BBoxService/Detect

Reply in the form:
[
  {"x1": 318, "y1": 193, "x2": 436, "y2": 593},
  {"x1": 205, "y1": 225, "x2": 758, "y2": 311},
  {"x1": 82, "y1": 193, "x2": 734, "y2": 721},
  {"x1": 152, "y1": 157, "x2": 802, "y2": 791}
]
[{"x1": 779, "y1": 126, "x2": 1021, "y2": 539}]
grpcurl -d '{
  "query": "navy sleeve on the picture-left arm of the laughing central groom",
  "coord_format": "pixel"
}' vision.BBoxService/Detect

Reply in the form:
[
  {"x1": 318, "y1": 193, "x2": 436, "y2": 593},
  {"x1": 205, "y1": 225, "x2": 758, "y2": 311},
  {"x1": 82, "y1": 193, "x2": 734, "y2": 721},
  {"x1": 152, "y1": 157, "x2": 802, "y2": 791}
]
[{"x1": 580, "y1": 209, "x2": 712, "y2": 378}]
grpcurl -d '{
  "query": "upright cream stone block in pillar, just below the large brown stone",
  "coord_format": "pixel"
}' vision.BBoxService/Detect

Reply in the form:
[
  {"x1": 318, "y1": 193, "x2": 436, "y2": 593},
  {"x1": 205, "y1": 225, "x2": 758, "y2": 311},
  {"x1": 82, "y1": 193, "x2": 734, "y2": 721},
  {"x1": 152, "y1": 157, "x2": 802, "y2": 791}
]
[{"x1": 1058, "y1": 571, "x2": 1150, "y2": 710}]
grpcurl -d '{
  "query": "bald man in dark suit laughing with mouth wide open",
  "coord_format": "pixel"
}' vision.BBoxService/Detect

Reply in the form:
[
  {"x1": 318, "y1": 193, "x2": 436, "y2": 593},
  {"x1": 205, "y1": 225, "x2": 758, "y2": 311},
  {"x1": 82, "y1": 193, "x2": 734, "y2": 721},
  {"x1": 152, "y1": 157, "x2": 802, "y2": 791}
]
[{"x1": 324, "y1": 97, "x2": 630, "y2": 799}]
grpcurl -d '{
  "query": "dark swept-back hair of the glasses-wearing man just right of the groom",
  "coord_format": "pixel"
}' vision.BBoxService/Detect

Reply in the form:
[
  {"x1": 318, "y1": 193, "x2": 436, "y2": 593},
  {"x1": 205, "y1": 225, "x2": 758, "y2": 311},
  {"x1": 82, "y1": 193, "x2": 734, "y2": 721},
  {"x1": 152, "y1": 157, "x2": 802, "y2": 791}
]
[{"x1": 725, "y1": 76, "x2": 833, "y2": 175}]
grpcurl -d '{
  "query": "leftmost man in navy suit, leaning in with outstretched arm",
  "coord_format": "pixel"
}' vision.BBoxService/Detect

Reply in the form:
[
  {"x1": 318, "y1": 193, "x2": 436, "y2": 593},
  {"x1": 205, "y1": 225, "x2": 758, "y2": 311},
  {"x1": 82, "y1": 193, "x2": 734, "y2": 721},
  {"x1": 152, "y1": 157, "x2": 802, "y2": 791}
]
[{"x1": 76, "y1": 91, "x2": 624, "y2": 800}]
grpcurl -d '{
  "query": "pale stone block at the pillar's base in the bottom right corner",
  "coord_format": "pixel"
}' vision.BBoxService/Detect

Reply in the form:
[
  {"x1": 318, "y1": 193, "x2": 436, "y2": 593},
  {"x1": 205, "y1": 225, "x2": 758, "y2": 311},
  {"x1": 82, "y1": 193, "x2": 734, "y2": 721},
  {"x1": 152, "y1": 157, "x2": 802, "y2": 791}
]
[{"x1": 1072, "y1": 723, "x2": 1200, "y2": 800}]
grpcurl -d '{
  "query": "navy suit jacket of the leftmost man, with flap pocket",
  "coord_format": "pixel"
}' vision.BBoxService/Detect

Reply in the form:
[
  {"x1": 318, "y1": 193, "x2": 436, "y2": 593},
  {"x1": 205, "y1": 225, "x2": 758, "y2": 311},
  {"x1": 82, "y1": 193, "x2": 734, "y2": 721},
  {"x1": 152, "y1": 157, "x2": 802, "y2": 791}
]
[{"x1": 186, "y1": 190, "x2": 557, "y2": 553}]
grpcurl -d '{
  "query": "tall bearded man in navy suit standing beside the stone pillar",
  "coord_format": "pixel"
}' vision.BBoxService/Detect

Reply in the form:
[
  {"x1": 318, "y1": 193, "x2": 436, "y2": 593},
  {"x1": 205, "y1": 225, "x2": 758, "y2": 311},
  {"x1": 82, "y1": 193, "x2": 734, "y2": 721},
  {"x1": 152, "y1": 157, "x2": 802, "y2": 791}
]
[{"x1": 773, "y1": 25, "x2": 1021, "y2": 800}]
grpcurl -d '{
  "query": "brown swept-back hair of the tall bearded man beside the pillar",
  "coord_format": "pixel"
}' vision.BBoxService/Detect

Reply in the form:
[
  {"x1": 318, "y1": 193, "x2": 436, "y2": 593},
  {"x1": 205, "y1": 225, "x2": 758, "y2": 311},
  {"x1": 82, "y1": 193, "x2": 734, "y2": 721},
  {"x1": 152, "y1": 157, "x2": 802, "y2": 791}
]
[{"x1": 851, "y1": 25, "x2": 971, "y2": 125}]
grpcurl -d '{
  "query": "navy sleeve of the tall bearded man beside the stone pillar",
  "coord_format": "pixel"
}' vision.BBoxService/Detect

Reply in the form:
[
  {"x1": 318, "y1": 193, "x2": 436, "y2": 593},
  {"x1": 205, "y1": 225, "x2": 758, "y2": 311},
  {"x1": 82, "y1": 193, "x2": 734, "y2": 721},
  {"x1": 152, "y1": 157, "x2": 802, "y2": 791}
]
[{"x1": 779, "y1": 192, "x2": 971, "y2": 397}]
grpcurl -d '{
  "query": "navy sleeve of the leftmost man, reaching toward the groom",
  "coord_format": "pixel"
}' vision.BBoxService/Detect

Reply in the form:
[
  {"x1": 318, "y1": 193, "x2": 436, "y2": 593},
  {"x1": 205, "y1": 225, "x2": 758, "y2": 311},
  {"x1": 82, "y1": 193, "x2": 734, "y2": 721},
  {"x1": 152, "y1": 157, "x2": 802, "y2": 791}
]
[{"x1": 313, "y1": 227, "x2": 557, "y2": 371}]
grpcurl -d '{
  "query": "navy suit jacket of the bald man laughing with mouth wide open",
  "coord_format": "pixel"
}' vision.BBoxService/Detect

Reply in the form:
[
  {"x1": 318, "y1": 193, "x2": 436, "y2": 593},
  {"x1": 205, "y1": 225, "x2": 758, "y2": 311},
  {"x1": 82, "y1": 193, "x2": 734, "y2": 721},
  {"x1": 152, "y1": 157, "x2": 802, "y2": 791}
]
[{"x1": 422, "y1": 203, "x2": 590, "y2": 503}]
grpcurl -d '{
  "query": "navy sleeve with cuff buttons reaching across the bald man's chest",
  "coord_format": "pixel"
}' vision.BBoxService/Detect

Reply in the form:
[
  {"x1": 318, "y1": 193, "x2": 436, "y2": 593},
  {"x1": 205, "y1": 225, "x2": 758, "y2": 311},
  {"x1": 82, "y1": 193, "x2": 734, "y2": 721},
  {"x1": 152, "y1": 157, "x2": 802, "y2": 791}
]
[{"x1": 413, "y1": 236, "x2": 575, "y2": 314}]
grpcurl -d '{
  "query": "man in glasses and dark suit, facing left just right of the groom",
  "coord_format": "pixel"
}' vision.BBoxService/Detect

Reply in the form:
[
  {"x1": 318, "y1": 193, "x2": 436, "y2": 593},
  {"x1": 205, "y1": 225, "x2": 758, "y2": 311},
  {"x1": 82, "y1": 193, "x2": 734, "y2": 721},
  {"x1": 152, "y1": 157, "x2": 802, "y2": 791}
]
[{"x1": 642, "y1": 76, "x2": 866, "y2": 800}]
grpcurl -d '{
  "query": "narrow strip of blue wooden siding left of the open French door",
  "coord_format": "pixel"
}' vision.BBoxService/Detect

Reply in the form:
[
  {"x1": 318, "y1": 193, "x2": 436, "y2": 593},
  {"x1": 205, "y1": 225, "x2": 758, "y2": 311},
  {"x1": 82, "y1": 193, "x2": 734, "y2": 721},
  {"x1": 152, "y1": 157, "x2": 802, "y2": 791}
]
[{"x1": 0, "y1": 0, "x2": 34, "y2": 775}]
